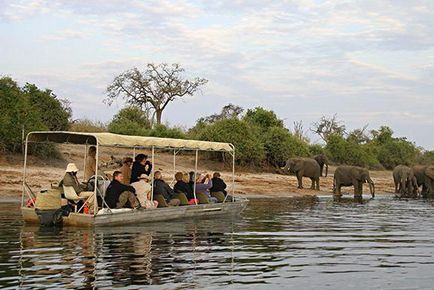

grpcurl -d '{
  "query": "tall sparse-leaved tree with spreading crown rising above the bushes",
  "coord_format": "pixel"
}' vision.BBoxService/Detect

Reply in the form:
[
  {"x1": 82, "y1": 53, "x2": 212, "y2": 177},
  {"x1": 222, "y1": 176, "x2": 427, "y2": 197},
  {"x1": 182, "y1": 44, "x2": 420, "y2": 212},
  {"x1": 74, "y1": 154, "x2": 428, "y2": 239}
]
[{"x1": 106, "y1": 63, "x2": 208, "y2": 124}]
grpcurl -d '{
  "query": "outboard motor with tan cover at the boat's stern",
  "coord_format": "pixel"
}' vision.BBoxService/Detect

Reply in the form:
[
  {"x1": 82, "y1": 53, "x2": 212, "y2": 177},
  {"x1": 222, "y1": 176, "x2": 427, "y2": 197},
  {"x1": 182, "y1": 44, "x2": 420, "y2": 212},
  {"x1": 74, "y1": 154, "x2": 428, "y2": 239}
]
[{"x1": 35, "y1": 189, "x2": 63, "y2": 226}]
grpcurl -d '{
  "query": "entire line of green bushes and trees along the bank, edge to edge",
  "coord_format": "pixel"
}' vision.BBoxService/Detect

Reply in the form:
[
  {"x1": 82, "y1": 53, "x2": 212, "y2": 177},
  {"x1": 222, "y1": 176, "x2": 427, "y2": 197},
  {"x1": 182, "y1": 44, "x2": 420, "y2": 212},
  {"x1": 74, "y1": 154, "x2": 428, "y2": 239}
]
[{"x1": 0, "y1": 77, "x2": 434, "y2": 169}]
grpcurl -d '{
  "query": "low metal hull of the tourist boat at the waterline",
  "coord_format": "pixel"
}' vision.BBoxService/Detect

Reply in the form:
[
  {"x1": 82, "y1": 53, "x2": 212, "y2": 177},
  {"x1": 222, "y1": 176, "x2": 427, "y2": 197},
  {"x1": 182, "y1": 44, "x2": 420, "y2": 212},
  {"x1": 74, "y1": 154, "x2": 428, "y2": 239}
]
[{"x1": 21, "y1": 199, "x2": 248, "y2": 226}]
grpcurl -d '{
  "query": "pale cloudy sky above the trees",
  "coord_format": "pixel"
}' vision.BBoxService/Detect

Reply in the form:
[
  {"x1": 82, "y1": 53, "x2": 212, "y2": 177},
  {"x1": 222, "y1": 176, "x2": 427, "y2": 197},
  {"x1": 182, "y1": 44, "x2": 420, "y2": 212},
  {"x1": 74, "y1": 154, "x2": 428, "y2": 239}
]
[{"x1": 0, "y1": 0, "x2": 434, "y2": 150}]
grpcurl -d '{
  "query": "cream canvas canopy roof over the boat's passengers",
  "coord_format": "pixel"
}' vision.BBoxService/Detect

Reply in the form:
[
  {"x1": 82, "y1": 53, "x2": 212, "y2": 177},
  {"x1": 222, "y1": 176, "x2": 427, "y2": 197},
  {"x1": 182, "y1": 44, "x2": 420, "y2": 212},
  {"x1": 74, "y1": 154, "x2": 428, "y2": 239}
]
[{"x1": 27, "y1": 131, "x2": 234, "y2": 152}]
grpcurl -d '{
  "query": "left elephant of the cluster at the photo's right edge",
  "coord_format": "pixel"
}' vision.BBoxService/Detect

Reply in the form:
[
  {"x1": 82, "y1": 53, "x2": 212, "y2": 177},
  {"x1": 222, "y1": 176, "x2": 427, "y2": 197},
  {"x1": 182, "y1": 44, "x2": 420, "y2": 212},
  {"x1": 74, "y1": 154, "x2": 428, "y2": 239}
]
[{"x1": 393, "y1": 165, "x2": 418, "y2": 197}]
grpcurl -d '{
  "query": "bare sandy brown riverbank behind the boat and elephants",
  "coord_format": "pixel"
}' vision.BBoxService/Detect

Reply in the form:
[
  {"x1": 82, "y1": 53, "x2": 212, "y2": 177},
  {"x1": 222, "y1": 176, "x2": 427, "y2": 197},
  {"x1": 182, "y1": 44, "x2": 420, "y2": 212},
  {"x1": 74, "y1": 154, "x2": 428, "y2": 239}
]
[{"x1": 0, "y1": 145, "x2": 393, "y2": 197}]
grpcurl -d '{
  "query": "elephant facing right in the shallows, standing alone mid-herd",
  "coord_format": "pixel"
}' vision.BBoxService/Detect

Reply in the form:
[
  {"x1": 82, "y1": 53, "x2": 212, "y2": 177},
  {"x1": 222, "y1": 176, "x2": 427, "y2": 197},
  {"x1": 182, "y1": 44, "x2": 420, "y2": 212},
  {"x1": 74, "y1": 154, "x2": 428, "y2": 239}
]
[{"x1": 333, "y1": 165, "x2": 375, "y2": 201}]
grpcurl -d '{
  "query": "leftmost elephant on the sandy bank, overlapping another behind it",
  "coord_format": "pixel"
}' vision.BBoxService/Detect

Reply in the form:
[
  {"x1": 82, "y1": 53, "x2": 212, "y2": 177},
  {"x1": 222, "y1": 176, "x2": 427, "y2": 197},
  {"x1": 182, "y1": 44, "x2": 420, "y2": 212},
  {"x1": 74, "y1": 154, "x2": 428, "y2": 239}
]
[{"x1": 283, "y1": 158, "x2": 320, "y2": 190}]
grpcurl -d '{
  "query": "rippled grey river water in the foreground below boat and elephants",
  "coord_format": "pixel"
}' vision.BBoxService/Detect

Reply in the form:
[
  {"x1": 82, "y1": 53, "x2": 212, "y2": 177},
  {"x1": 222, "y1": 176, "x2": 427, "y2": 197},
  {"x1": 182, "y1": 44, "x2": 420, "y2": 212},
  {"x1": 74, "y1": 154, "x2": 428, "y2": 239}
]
[{"x1": 0, "y1": 197, "x2": 434, "y2": 289}]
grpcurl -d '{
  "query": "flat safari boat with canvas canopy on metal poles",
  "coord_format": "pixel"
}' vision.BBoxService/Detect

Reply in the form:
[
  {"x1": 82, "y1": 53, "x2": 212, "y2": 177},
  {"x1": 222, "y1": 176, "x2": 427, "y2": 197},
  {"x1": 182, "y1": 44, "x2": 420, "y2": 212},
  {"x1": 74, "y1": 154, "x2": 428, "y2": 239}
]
[{"x1": 21, "y1": 131, "x2": 248, "y2": 226}]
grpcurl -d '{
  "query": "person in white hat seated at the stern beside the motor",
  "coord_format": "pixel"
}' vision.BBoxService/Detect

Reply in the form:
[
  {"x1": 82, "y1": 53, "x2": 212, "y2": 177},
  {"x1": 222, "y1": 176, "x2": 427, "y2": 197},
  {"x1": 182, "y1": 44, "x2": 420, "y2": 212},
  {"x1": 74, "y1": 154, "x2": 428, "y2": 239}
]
[{"x1": 59, "y1": 163, "x2": 95, "y2": 210}]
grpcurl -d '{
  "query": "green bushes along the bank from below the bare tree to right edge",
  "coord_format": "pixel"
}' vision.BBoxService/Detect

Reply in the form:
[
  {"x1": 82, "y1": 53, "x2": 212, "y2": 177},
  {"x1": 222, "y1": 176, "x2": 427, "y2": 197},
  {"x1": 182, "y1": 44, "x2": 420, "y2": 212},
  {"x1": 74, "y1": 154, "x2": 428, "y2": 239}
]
[{"x1": 92, "y1": 104, "x2": 434, "y2": 169}]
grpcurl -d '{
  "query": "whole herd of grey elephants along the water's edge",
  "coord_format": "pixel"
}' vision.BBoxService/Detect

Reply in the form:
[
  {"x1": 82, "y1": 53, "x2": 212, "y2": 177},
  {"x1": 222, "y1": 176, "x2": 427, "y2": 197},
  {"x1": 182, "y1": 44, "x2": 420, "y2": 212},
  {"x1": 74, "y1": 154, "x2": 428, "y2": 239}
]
[{"x1": 282, "y1": 154, "x2": 434, "y2": 201}]
